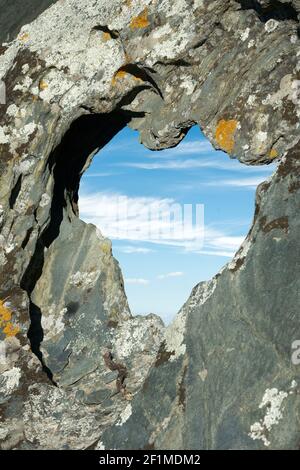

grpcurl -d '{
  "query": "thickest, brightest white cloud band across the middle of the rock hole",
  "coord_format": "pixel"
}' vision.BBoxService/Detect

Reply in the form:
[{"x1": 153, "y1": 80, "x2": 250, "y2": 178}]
[{"x1": 80, "y1": 192, "x2": 244, "y2": 257}]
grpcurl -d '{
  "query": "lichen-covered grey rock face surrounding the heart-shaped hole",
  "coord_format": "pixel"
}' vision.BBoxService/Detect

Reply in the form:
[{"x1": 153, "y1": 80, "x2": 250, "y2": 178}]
[{"x1": 0, "y1": 0, "x2": 300, "y2": 449}]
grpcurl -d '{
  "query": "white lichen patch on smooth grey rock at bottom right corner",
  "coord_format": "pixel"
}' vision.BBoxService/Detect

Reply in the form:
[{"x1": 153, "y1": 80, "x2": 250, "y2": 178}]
[{"x1": 249, "y1": 388, "x2": 288, "y2": 447}]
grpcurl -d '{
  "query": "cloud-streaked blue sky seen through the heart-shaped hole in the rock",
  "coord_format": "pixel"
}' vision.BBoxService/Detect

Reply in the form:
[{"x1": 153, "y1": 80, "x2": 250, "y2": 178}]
[{"x1": 79, "y1": 126, "x2": 275, "y2": 323}]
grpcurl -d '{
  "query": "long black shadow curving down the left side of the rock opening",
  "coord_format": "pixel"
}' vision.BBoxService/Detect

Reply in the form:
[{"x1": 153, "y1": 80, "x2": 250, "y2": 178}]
[{"x1": 19, "y1": 112, "x2": 131, "y2": 385}]
